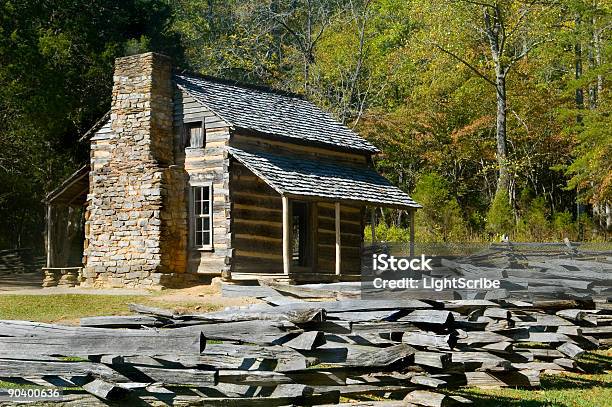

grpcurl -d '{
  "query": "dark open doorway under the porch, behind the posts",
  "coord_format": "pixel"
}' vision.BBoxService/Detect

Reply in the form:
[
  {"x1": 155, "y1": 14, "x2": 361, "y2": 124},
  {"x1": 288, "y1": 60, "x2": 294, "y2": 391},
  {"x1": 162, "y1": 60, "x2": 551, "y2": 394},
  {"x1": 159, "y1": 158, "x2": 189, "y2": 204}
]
[{"x1": 291, "y1": 201, "x2": 312, "y2": 267}]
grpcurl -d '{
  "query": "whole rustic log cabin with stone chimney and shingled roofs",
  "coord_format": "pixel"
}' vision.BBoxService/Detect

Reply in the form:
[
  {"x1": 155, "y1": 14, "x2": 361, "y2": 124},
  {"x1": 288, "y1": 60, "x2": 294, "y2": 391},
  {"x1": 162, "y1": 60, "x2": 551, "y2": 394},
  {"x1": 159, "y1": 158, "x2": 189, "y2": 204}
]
[{"x1": 46, "y1": 53, "x2": 420, "y2": 287}]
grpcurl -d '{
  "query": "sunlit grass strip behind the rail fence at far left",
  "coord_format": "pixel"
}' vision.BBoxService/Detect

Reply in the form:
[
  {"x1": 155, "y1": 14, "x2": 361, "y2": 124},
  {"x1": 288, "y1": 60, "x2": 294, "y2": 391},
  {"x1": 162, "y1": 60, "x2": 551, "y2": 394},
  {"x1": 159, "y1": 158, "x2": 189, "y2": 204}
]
[{"x1": 0, "y1": 294, "x2": 218, "y2": 323}]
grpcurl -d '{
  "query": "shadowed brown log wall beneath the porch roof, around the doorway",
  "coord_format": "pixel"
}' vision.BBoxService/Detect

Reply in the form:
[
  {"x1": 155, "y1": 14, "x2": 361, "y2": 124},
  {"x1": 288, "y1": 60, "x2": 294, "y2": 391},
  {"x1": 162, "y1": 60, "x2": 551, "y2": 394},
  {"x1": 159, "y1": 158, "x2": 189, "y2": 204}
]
[{"x1": 230, "y1": 161, "x2": 363, "y2": 275}]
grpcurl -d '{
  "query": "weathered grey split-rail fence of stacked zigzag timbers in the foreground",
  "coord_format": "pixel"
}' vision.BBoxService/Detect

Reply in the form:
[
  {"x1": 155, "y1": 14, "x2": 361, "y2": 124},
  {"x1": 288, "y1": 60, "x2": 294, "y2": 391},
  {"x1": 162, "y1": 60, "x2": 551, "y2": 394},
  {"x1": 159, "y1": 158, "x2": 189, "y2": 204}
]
[{"x1": 0, "y1": 255, "x2": 612, "y2": 407}]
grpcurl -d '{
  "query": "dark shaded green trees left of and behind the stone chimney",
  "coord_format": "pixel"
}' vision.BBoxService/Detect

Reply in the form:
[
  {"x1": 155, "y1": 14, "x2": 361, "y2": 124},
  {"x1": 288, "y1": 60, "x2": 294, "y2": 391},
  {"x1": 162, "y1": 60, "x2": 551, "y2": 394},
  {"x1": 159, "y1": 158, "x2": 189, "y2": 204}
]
[{"x1": 0, "y1": 0, "x2": 182, "y2": 250}]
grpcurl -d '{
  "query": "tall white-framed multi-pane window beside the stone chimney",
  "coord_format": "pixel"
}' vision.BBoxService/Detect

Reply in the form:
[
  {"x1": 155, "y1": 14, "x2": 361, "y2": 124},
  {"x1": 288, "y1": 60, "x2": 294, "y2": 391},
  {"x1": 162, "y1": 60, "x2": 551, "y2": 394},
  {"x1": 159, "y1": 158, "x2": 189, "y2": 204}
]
[{"x1": 191, "y1": 185, "x2": 213, "y2": 249}]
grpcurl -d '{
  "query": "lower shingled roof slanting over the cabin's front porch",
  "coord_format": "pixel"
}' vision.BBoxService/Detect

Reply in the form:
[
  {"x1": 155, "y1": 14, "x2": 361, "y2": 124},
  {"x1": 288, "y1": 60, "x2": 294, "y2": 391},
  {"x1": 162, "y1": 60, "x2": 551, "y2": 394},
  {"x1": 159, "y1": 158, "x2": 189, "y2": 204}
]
[{"x1": 228, "y1": 147, "x2": 421, "y2": 209}]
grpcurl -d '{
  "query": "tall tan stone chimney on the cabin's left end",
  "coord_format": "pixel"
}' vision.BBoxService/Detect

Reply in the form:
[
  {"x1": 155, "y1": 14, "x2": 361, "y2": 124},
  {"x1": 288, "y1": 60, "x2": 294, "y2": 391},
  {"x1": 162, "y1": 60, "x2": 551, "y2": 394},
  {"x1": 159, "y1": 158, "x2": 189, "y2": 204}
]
[{"x1": 83, "y1": 53, "x2": 187, "y2": 287}]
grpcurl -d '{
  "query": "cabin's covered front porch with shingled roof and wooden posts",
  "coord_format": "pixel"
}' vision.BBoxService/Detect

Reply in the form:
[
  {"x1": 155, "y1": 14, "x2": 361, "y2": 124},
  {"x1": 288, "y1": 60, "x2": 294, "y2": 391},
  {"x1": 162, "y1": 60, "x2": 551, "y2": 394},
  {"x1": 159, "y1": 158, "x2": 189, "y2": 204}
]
[{"x1": 224, "y1": 147, "x2": 420, "y2": 282}]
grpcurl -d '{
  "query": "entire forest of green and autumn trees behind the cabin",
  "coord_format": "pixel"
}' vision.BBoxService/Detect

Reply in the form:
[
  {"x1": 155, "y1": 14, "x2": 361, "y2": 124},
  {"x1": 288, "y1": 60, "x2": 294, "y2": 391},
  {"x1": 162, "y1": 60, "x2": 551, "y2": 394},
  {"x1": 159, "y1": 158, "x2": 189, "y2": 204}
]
[{"x1": 0, "y1": 0, "x2": 612, "y2": 250}]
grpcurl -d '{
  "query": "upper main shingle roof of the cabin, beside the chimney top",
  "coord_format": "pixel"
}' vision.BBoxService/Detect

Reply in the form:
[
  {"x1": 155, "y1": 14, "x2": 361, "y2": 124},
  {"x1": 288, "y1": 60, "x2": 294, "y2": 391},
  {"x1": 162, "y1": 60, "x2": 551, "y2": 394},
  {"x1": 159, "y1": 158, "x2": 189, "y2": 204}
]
[{"x1": 174, "y1": 74, "x2": 379, "y2": 153}]
